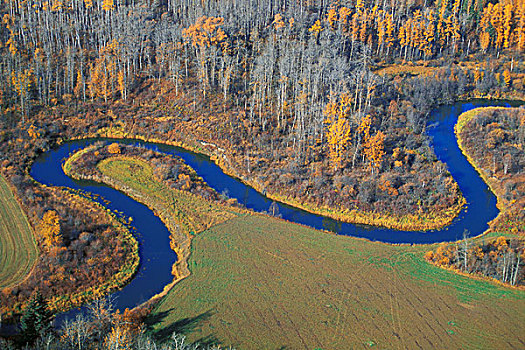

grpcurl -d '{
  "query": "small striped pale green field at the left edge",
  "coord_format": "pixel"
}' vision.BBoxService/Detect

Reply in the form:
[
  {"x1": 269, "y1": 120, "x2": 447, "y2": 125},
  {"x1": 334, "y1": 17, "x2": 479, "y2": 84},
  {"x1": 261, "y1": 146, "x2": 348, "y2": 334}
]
[{"x1": 0, "y1": 175, "x2": 38, "y2": 289}]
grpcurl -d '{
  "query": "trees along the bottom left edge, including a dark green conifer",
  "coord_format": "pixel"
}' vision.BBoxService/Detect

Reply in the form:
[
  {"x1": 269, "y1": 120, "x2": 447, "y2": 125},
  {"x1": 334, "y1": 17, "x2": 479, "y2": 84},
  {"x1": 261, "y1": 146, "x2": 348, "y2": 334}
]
[{"x1": 0, "y1": 292, "x2": 229, "y2": 350}]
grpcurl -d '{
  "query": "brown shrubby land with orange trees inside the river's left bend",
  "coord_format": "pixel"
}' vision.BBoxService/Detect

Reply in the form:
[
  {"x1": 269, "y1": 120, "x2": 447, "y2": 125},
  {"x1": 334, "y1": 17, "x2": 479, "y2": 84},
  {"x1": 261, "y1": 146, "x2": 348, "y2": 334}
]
[{"x1": 0, "y1": 180, "x2": 139, "y2": 321}]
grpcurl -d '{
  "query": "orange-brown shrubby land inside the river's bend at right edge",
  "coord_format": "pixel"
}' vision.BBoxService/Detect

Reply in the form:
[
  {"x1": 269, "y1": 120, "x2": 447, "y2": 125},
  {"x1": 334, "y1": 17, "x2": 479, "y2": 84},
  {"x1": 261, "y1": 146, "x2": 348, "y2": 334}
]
[{"x1": 456, "y1": 107, "x2": 525, "y2": 235}]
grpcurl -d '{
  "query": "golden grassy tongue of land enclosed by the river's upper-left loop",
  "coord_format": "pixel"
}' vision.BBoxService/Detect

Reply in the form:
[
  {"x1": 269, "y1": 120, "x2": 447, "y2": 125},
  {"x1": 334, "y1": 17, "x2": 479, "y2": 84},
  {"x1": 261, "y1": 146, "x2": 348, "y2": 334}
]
[{"x1": 63, "y1": 144, "x2": 247, "y2": 304}]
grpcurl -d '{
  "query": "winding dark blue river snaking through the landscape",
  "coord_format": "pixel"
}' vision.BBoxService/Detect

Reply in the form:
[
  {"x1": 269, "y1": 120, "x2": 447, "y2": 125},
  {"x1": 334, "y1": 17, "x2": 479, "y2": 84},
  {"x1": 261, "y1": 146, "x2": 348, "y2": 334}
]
[{"x1": 27, "y1": 100, "x2": 510, "y2": 323}]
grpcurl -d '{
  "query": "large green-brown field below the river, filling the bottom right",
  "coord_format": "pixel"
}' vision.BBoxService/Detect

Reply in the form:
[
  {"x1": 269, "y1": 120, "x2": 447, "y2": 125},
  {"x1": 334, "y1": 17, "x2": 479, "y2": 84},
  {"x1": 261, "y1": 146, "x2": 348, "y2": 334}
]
[{"x1": 150, "y1": 215, "x2": 525, "y2": 349}]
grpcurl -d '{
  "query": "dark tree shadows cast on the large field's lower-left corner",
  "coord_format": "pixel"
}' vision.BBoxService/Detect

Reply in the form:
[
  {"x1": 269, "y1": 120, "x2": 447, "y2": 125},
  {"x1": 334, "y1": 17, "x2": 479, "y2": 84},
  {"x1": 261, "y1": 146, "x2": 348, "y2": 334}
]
[{"x1": 146, "y1": 309, "x2": 217, "y2": 345}]
